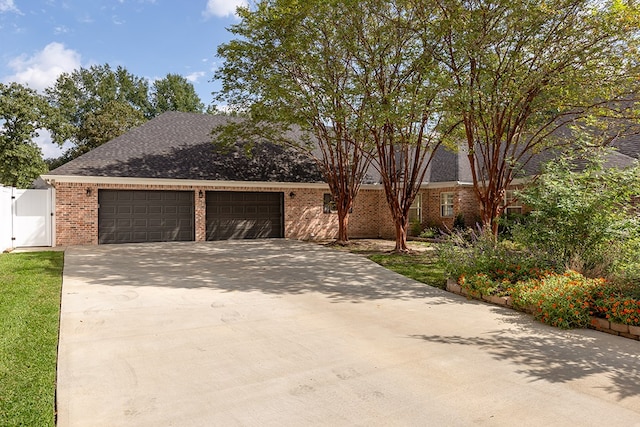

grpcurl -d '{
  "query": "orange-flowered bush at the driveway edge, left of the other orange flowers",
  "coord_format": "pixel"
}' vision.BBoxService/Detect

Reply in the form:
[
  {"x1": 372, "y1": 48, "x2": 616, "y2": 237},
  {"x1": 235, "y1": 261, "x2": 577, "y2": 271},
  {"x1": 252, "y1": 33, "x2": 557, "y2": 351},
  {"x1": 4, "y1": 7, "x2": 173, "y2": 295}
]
[{"x1": 511, "y1": 270, "x2": 606, "y2": 329}]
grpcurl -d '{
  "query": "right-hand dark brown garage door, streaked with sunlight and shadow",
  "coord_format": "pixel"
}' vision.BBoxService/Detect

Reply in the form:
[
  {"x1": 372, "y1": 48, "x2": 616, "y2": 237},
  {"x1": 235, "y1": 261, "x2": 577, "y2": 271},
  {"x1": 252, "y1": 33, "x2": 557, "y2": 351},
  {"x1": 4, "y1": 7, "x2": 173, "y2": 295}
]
[{"x1": 207, "y1": 191, "x2": 284, "y2": 240}]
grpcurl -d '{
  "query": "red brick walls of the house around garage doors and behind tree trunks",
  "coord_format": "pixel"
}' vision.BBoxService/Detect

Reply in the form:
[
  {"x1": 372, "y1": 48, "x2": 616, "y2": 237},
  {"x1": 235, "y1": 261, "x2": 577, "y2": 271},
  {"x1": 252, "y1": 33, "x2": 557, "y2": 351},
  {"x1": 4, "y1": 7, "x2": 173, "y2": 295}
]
[{"x1": 55, "y1": 182, "x2": 479, "y2": 246}]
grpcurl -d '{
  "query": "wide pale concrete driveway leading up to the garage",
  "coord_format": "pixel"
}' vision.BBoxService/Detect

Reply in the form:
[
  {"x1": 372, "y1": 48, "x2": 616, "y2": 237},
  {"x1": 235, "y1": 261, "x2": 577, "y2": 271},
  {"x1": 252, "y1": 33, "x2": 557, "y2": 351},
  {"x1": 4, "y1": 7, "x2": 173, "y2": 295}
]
[{"x1": 57, "y1": 240, "x2": 640, "y2": 427}]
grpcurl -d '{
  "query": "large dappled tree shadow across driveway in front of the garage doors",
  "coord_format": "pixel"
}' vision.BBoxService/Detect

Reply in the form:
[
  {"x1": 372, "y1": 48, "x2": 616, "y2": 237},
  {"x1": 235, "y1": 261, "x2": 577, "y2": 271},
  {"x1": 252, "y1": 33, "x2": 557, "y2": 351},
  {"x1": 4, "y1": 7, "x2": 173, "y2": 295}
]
[{"x1": 65, "y1": 240, "x2": 459, "y2": 304}]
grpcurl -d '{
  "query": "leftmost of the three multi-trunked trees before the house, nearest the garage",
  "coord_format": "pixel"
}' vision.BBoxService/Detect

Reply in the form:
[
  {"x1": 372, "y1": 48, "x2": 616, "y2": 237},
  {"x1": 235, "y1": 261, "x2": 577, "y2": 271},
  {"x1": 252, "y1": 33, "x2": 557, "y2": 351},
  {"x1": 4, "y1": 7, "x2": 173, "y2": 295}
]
[{"x1": 214, "y1": 0, "x2": 372, "y2": 244}]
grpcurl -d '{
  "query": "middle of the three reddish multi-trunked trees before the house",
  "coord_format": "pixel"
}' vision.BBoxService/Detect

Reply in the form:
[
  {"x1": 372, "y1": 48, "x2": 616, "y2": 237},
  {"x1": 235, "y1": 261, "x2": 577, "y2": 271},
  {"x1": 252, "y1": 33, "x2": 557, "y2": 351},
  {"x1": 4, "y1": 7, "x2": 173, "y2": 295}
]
[{"x1": 350, "y1": 0, "x2": 455, "y2": 252}]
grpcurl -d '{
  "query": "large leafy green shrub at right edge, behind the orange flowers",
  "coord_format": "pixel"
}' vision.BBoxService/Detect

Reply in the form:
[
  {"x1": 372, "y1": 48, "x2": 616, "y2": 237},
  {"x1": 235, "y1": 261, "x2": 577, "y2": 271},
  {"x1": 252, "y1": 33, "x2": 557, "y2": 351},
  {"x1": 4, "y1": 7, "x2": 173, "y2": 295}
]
[{"x1": 512, "y1": 156, "x2": 640, "y2": 277}]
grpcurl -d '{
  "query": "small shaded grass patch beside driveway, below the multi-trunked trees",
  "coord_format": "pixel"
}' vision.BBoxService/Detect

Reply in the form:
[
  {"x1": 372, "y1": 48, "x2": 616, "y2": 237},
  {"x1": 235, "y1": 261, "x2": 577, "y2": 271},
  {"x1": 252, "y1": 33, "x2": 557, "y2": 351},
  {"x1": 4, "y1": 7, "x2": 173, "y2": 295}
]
[{"x1": 368, "y1": 252, "x2": 446, "y2": 289}]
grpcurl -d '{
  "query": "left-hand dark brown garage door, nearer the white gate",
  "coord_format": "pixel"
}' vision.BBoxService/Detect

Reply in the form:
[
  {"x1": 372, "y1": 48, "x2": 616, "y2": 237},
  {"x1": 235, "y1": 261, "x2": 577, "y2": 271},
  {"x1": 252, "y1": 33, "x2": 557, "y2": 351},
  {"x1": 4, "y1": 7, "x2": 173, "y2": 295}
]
[{"x1": 98, "y1": 190, "x2": 195, "y2": 243}]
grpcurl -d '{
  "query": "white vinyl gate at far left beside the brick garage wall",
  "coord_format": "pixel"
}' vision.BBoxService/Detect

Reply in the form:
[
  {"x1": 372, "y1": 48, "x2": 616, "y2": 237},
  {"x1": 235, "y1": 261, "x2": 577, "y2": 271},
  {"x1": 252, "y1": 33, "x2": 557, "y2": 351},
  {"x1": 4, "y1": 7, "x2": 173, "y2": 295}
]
[{"x1": 0, "y1": 187, "x2": 54, "y2": 250}]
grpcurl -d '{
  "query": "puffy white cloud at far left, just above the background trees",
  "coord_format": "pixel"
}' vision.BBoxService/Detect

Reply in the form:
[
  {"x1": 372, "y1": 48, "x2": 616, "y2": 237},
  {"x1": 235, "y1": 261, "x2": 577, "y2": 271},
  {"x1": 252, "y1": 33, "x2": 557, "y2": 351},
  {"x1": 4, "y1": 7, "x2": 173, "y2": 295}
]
[{"x1": 0, "y1": 42, "x2": 80, "y2": 92}]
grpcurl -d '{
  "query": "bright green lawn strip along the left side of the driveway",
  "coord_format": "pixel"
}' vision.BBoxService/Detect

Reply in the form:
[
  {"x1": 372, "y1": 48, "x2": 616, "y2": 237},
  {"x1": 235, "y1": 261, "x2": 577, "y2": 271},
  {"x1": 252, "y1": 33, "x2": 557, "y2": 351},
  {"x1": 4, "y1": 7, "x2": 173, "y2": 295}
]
[{"x1": 0, "y1": 252, "x2": 63, "y2": 426}]
